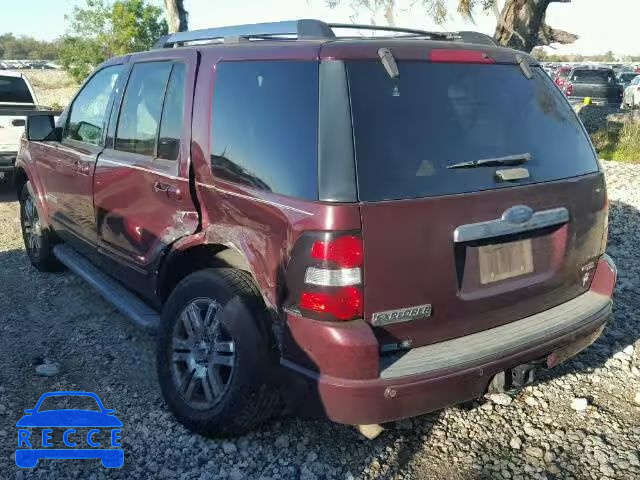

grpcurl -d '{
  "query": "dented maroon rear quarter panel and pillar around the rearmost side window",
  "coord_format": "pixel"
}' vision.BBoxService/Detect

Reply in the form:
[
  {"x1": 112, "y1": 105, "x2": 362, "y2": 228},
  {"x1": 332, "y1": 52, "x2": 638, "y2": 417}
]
[{"x1": 186, "y1": 44, "x2": 361, "y2": 310}]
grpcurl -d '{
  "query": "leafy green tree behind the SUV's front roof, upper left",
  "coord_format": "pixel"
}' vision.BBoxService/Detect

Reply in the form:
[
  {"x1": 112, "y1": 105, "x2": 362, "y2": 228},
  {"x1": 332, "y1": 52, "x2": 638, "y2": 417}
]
[{"x1": 60, "y1": 0, "x2": 167, "y2": 82}]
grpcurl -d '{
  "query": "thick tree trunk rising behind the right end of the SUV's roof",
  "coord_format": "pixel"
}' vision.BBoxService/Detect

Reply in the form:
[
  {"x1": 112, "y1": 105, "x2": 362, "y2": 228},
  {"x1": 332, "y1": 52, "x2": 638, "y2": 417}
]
[{"x1": 494, "y1": 0, "x2": 578, "y2": 52}]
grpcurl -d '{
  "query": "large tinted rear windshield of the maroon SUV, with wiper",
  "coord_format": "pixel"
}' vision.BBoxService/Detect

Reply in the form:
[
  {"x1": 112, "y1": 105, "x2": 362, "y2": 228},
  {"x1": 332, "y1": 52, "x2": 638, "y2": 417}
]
[{"x1": 347, "y1": 61, "x2": 598, "y2": 201}]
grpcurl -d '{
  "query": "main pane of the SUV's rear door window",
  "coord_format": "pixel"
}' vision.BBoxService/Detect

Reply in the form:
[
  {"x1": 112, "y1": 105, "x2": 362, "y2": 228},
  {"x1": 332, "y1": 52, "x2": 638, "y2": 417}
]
[{"x1": 115, "y1": 62, "x2": 172, "y2": 156}]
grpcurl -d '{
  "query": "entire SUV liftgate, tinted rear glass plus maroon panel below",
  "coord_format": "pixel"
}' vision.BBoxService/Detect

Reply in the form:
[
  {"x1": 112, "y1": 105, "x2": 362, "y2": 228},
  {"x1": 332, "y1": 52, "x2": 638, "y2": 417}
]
[{"x1": 347, "y1": 61, "x2": 607, "y2": 348}]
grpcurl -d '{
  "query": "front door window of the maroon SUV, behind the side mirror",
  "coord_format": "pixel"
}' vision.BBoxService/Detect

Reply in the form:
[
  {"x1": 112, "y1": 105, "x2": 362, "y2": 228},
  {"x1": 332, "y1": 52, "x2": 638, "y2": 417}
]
[{"x1": 64, "y1": 65, "x2": 124, "y2": 145}]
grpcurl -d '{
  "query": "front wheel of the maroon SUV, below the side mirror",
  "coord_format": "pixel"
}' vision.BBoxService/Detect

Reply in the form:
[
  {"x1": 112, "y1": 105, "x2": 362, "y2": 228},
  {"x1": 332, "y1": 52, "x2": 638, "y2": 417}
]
[{"x1": 20, "y1": 182, "x2": 63, "y2": 272}]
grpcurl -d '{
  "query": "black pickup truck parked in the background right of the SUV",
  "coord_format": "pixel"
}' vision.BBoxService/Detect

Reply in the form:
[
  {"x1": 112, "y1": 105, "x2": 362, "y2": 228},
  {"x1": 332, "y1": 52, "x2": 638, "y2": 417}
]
[{"x1": 563, "y1": 67, "x2": 624, "y2": 105}]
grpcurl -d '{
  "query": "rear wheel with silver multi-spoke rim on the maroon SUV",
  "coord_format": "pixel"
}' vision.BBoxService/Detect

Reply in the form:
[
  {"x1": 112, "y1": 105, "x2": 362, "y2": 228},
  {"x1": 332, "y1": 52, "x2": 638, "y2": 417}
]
[{"x1": 156, "y1": 268, "x2": 279, "y2": 437}]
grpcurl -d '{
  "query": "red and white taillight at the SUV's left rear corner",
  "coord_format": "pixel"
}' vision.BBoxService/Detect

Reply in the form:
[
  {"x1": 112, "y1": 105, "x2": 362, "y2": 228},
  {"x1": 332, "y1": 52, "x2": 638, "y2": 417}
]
[{"x1": 286, "y1": 232, "x2": 364, "y2": 321}]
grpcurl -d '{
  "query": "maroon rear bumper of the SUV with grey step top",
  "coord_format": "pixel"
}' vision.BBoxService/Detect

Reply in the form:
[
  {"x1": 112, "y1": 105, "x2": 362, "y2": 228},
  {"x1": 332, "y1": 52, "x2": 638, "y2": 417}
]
[{"x1": 283, "y1": 256, "x2": 616, "y2": 424}]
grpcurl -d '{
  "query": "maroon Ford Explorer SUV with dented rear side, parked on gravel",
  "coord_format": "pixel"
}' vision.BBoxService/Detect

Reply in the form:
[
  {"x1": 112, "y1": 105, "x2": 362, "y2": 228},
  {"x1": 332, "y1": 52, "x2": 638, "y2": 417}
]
[{"x1": 16, "y1": 20, "x2": 616, "y2": 435}]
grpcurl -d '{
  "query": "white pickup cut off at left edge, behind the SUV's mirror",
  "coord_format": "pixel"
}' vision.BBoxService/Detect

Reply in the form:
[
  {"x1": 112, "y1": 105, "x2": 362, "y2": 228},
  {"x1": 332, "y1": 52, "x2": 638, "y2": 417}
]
[{"x1": 0, "y1": 70, "x2": 38, "y2": 180}]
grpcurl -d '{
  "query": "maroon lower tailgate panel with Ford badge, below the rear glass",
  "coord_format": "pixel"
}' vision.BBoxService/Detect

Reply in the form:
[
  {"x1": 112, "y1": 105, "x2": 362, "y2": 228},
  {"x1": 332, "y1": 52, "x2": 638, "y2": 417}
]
[{"x1": 361, "y1": 173, "x2": 606, "y2": 346}]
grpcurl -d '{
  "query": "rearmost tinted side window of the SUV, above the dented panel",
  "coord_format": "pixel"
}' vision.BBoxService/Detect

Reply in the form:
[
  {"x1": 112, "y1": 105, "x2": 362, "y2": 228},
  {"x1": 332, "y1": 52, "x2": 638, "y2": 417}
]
[{"x1": 211, "y1": 61, "x2": 318, "y2": 200}]
